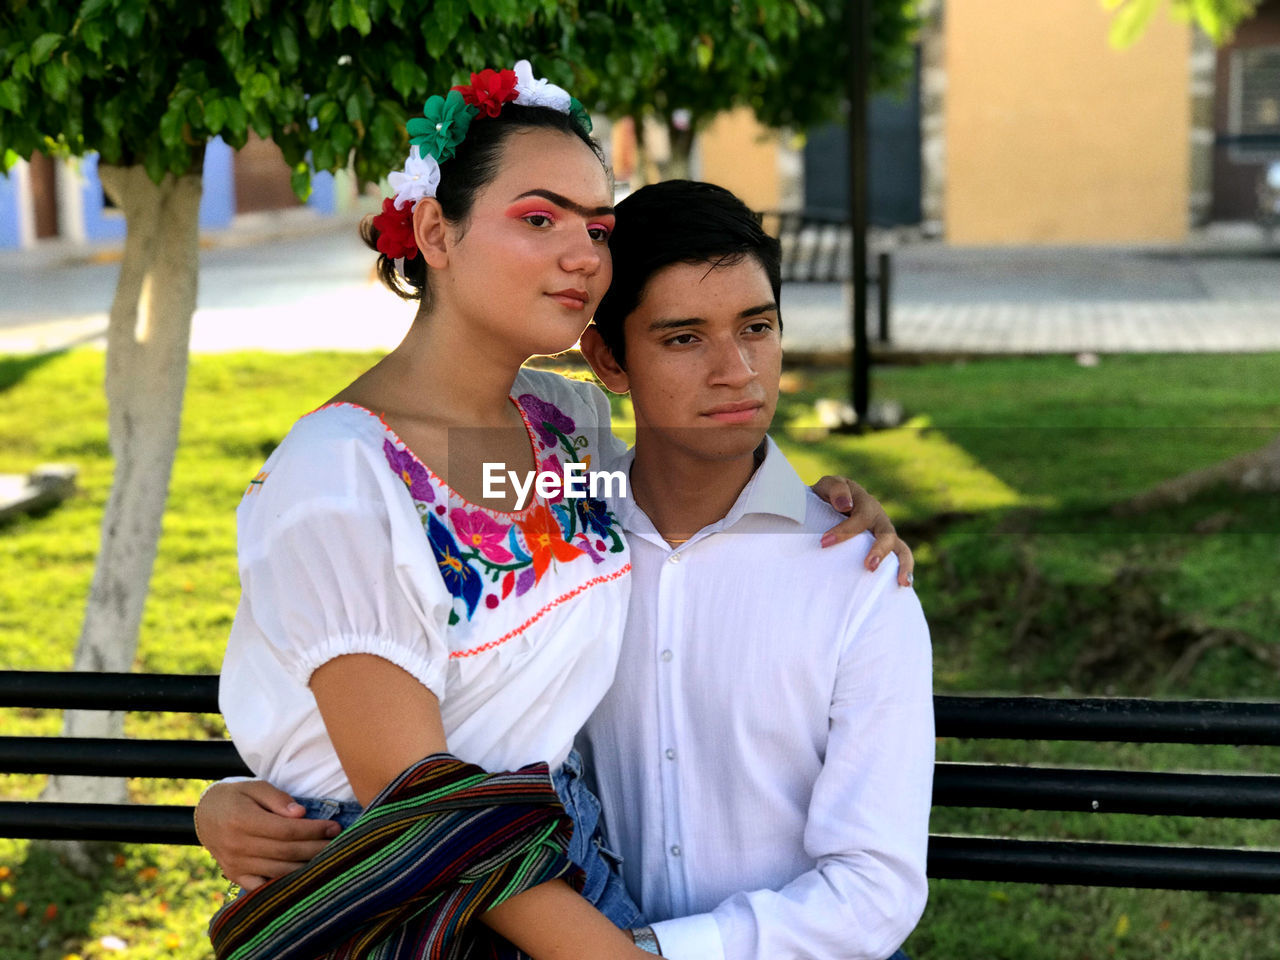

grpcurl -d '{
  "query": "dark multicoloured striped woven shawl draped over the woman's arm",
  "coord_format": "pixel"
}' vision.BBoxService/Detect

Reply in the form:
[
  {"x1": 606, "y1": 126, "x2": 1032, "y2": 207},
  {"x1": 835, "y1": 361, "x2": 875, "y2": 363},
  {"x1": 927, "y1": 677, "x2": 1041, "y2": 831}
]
[{"x1": 209, "y1": 754, "x2": 581, "y2": 960}]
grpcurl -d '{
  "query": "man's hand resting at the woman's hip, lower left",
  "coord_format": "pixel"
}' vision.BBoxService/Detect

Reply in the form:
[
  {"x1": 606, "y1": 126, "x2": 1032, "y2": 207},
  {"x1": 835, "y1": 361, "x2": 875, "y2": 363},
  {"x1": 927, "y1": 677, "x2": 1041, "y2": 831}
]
[{"x1": 196, "y1": 780, "x2": 339, "y2": 890}]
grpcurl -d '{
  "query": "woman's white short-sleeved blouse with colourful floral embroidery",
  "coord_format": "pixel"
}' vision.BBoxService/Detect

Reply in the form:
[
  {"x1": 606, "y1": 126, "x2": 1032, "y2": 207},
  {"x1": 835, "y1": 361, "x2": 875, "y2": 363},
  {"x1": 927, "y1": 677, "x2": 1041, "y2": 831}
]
[{"x1": 219, "y1": 370, "x2": 631, "y2": 800}]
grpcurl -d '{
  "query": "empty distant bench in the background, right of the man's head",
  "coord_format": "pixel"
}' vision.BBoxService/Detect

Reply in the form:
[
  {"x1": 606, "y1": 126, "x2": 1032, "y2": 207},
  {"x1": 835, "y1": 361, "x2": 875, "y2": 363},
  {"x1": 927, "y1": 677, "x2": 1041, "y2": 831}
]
[{"x1": 760, "y1": 210, "x2": 893, "y2": 343}]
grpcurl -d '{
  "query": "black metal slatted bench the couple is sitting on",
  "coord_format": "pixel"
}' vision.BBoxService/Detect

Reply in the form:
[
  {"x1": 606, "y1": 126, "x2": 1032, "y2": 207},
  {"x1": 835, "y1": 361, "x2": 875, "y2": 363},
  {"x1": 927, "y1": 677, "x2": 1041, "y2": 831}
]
[{"x1": 0, "y1": 671, "x2": 1280, "y2": 893}]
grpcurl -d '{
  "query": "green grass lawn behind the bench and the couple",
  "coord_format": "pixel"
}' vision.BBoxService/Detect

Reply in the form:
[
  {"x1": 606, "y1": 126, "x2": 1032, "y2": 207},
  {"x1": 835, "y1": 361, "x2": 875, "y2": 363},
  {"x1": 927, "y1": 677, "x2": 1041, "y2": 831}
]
[{"x1": 0, "y1": 351, "x2": 1280, "y2": 960}]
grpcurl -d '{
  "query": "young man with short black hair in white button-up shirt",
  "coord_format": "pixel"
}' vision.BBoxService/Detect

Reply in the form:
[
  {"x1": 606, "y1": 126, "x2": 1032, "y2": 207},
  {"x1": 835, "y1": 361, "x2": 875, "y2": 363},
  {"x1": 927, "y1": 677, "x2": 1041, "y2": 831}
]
[{"x1": 201, "y1": 182, "x2": 933, "y2": 960}]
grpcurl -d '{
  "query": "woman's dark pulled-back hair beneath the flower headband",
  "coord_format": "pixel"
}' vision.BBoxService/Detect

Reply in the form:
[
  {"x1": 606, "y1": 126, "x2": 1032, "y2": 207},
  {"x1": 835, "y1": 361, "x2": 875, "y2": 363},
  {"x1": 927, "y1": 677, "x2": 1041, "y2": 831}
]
[{"x1": 360, "y1": 104, "x2": 604, "y2": 305}]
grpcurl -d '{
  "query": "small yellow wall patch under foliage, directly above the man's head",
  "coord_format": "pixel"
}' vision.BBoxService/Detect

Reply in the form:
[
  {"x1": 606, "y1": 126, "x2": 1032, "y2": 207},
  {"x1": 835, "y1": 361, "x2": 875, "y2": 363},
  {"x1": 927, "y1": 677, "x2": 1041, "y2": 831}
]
[{"x1": 698, "y1": 106, "x2": 781, "y2": 210}]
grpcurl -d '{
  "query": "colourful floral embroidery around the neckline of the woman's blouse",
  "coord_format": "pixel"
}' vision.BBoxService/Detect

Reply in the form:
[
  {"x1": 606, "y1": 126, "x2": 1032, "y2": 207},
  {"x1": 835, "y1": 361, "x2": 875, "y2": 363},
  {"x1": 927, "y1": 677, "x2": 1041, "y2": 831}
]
[{"x1": 383, "y1": 393, "x2": 626, "y2": 625}]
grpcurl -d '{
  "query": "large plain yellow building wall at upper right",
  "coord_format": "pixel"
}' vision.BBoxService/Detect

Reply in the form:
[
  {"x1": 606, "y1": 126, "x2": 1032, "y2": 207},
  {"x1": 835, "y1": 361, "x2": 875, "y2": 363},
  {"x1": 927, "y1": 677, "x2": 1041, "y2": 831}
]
[{"x1": 943, "y1": 0, "x2": 1190, "y2": 244}]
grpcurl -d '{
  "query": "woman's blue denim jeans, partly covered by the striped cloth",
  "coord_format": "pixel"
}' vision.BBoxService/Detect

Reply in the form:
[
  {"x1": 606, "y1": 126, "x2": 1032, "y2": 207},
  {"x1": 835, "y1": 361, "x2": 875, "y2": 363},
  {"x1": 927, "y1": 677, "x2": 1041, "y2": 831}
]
[{"x1": 296, "y1": 750, "x2": 643, "y2": 929}]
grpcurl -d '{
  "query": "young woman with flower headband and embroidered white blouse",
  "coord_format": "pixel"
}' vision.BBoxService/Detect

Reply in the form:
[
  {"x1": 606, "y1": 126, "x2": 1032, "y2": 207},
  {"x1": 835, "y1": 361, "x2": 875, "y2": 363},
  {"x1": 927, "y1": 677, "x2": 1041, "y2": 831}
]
[{"x1": 198, "y1": 61, "x2": 911, "y2": 960}]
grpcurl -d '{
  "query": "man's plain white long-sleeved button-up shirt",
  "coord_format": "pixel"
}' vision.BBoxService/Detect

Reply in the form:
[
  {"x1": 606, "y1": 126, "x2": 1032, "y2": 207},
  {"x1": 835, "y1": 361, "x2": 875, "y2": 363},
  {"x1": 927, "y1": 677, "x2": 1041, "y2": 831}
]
[{"x1": 579, "y1": 440, "x2": 933, "y2": 960}]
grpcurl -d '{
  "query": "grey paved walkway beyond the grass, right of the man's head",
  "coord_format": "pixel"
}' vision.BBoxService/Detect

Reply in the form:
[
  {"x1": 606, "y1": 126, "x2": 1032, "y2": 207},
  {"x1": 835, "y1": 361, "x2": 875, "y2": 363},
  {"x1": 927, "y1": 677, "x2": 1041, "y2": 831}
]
[{"x1": 783, "y1": 243, "x2": 1280, "y2": 355}]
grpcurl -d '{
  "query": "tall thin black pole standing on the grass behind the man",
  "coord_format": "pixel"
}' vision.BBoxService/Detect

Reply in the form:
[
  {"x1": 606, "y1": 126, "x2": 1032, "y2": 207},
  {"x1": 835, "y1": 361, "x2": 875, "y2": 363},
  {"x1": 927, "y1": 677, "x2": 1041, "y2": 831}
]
[{"x1": 847, "y1": 0, "x2": 872, "y2": 428}]
